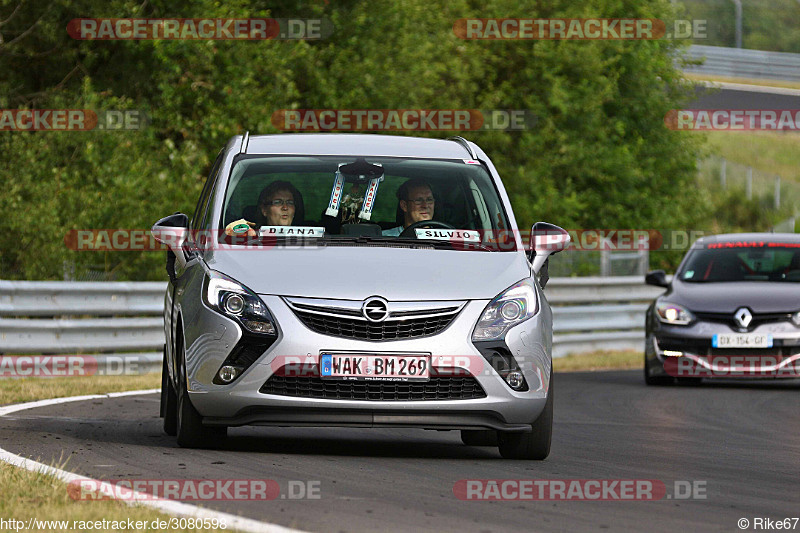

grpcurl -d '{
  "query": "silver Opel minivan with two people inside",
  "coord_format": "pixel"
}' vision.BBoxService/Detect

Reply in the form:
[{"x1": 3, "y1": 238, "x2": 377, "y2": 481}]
[{"x1": 153, "y1": 134, "x2": 569, "y2": 459}]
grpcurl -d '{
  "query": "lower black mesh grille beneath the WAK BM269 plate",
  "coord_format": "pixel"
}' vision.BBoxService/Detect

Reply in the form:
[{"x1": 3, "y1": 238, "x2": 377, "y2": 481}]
[{"x1": 259, "y1": 368, "x2": 486, "y2": 402}]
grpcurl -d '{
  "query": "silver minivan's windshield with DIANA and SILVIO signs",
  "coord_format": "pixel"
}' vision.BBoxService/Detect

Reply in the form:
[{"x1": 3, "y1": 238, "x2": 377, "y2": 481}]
[{"x1": 220, "y1": 156, "x2": 515, "y2": 251}]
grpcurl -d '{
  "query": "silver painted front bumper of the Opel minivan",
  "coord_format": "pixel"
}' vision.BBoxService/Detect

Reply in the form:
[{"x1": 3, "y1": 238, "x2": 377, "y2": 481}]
[{"x1": 186, "y1": 296, "x2": 552, "y2": 431}]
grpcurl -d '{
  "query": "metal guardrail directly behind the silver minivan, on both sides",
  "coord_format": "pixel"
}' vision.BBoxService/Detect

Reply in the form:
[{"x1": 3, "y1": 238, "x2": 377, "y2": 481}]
[{"x1": 0, "y1": 276, "x2": 662, "y2": 364}]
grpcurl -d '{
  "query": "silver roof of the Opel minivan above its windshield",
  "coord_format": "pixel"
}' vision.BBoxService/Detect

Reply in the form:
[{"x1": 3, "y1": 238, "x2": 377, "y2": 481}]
[{"x1": 245, "y1": 133, "x2": 472, "y2": 159}]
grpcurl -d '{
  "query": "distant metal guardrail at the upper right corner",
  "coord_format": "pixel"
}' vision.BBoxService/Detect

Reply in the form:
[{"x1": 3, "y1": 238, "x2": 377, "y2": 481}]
[{"x1": 684, "y1": 45, "x2": 800, "y2": 81}]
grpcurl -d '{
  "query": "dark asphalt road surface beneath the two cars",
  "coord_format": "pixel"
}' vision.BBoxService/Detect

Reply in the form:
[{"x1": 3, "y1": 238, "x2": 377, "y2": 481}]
[{"x1": 0, "y1": 371, "x2": 800, "y2": 533}]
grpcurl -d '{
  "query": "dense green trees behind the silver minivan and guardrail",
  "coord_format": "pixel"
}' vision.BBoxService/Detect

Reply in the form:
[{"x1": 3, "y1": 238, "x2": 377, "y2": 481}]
[{"x1": 0, "y1": 0, "x2": 709, "y2": 280}]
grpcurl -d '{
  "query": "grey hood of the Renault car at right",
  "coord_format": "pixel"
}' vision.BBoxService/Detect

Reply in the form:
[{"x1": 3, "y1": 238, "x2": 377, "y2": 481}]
[{"x1": 664, "y1": 280, "x2": 800, "y2": 313}]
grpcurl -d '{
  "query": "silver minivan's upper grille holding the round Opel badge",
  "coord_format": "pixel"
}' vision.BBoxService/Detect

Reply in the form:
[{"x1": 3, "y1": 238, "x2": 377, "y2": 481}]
[{"x1": 294, "y1": 309, "x2": 458, "y2": 341}]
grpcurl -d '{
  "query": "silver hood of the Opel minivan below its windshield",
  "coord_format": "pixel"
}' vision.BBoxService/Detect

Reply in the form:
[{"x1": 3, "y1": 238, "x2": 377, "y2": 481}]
[{"x1": 206, "y1": 247, "x2": 531, "y2": 301}]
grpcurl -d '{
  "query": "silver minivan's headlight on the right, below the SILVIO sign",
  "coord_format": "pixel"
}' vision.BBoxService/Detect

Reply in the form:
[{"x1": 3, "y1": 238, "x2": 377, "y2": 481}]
[{"x1": 472, "y1": 278, "x2": 539, "y2": 341}]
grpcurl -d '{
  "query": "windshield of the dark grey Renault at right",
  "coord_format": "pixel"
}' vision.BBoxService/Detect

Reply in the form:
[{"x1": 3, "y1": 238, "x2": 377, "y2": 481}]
[{"x1": 678, "y1": 241, "x2": 800, "y2": 282}]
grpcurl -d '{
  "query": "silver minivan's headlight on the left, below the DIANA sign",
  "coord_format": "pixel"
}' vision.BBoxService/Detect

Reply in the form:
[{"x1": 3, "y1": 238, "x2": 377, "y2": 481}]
[{"x1": 203, "y1": 272, "x2": 277, "y2": 335}]
